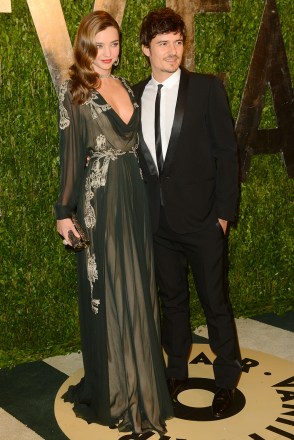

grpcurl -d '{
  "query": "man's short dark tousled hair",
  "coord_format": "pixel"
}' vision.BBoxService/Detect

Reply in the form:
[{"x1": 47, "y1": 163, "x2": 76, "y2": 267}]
[{"x1": 140, "y1": 8, "x2": 187, "y2": 47}]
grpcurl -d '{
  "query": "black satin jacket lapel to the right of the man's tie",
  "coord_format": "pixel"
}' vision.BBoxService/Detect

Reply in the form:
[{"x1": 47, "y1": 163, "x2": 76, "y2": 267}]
[{"x1": 163, "y1": 69, "x2": 189, "y2": 173}]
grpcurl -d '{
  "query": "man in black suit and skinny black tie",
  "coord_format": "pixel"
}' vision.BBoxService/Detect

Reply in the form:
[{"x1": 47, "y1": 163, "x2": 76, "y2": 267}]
[{"x1": 134, "y1": 8, "x2": 241, "y2": 418}]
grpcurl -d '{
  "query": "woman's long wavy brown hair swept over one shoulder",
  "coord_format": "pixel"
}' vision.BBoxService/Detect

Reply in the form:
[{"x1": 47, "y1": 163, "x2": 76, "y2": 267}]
[{"x1": 69, "y1": 11, "x2": 120, "y2": 104}]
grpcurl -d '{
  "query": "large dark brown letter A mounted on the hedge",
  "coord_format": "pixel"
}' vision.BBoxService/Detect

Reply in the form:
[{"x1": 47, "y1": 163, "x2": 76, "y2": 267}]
[{"x1": 236, "y1": 0, "x2": 294, "y2": 180}]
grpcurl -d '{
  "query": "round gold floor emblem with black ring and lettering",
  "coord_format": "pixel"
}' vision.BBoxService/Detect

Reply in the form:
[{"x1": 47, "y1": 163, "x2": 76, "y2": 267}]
[{"x1": 54, "y1": 344, "x2": 294, "y2": 440}]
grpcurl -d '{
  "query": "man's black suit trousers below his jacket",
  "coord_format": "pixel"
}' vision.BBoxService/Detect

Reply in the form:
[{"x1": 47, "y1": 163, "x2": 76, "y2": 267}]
[{"x1": 154, "y1": 207, "x2": 241, "y2": 389}]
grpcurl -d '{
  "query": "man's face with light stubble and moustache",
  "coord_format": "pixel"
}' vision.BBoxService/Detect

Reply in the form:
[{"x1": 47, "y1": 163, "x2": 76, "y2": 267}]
[{"x1": 142, "y1": 32, "x2": 184, "y2": 82}]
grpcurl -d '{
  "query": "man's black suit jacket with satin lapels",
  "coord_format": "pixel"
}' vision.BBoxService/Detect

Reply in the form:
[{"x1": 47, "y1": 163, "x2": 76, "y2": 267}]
[{"x1": 133, "y1": 69, "x2": 238, "y2": 233}]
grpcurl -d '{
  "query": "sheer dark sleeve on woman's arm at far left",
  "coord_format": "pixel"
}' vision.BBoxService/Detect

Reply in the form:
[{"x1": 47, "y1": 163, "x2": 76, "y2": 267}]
[{"x1": 55, "y1": 83, "x2": 86, "y2": 220}]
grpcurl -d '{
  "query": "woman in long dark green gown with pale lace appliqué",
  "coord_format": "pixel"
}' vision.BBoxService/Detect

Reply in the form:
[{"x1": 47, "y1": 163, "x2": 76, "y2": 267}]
[{"x1": 56, "y1": 11, "x2": 172, "y2": 433}]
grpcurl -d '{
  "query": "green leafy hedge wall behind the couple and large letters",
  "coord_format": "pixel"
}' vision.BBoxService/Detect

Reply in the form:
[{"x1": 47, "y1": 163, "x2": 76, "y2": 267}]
[{"x1": 0, "y1": 0, "x2": 294, "y2": 366}]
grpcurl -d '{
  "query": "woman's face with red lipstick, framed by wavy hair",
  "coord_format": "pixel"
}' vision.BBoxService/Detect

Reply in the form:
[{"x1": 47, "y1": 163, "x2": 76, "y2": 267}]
[{"x1": 93, "y1": 26, "x2": 119, "y2": 75}]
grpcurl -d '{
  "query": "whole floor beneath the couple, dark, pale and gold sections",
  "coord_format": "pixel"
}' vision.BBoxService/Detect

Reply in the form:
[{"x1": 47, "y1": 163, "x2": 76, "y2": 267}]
[{"x1": 0, "y1": 311, "x2": 294, "y2": 440}]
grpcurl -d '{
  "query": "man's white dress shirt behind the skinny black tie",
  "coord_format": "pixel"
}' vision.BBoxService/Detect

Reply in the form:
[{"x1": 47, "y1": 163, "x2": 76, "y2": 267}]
[{"x1": 141, "y1": 69, "x2": 181, "y2": 172}]
